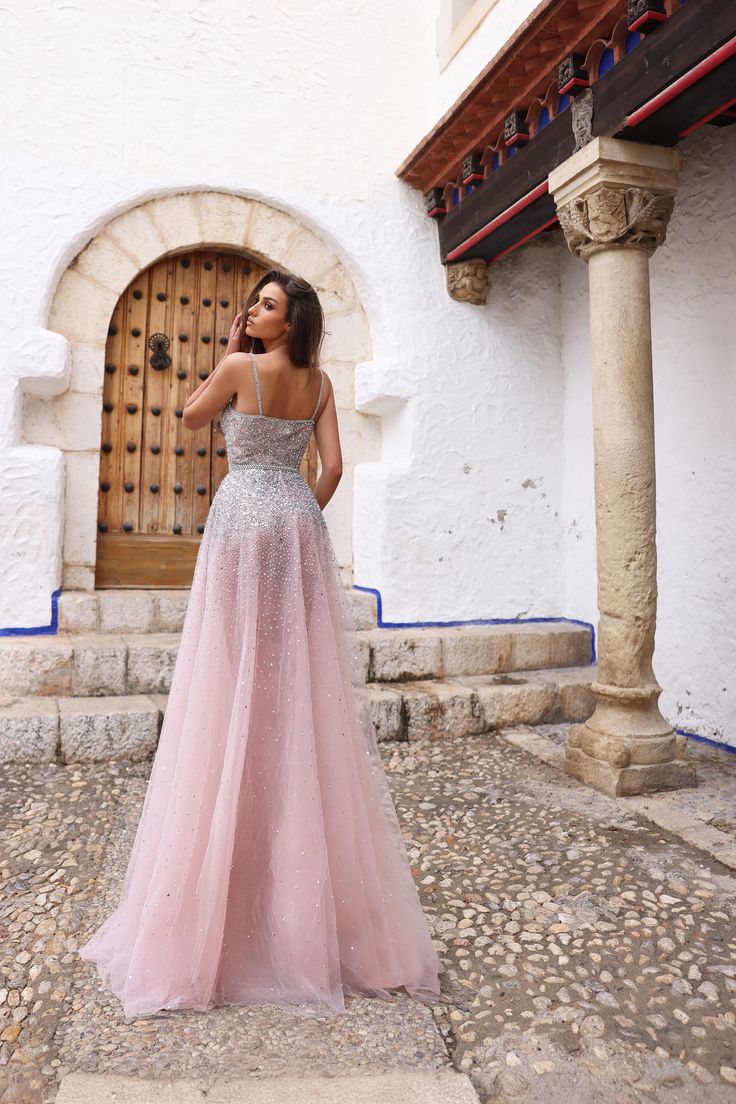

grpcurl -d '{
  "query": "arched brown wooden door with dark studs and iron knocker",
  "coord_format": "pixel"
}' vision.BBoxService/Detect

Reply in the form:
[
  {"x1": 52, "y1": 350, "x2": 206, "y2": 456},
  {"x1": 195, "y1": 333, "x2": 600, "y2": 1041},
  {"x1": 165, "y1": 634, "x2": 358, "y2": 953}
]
[{"x1": 95, "y1": 251, "x2": 317, "y2": 587}]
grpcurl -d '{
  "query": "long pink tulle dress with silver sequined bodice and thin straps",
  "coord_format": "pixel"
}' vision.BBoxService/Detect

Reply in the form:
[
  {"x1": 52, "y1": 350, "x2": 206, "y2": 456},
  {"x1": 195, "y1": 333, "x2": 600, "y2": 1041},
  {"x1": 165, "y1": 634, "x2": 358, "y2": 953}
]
[{"x1": 79, "y1": 358, "x2": 440, "y2": 1020}]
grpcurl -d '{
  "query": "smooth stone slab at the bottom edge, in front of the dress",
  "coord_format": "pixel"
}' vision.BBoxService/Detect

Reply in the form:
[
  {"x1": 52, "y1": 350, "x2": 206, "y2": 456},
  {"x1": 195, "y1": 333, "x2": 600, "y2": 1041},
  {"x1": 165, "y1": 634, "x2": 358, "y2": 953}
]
[{"x1": 56, "y1": 1070, "x2": 478, "y2": 1104}]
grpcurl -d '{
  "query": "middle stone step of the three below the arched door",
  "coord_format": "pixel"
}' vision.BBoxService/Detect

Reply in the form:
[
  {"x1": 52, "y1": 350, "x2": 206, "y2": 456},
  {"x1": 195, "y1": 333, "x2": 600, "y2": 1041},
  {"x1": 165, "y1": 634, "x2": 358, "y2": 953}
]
[{"x1": 0, "y1": 622, "x2": 591, "y2": 698}]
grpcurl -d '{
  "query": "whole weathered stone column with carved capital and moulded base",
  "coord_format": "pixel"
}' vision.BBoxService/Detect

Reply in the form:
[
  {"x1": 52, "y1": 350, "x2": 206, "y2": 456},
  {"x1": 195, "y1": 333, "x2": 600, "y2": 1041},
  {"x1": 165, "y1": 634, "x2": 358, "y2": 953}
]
[{"x1": 550, "y1": 137, "x2": 697, "y2": 796}]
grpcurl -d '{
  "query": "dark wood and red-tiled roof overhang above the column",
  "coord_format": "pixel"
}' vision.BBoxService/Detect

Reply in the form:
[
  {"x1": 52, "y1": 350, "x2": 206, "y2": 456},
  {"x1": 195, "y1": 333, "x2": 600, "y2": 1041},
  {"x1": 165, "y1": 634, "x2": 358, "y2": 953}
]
[{"x1": 396, "y1": 0, "x2": 736, "y2": 276}]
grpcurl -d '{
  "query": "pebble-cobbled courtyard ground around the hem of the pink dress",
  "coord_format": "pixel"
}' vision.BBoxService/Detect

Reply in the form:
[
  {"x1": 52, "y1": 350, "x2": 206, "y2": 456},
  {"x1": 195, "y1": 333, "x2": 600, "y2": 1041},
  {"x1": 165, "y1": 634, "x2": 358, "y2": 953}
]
[{"x1": 0, "y1": 732, "x2": 736, "y2": 1104}]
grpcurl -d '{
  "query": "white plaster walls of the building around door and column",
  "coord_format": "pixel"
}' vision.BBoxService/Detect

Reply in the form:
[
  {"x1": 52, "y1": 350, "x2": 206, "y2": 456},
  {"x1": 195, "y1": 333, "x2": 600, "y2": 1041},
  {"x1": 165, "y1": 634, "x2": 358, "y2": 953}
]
[{"x1": 0, "y1": 0, "x2": 736, "y2": 746}]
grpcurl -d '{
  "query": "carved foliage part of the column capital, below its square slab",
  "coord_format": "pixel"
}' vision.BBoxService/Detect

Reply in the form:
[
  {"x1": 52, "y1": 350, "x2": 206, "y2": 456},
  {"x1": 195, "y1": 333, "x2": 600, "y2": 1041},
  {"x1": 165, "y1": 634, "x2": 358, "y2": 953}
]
[{"x1": 557, "y1": 184, "x2": 674, "y2": 261}]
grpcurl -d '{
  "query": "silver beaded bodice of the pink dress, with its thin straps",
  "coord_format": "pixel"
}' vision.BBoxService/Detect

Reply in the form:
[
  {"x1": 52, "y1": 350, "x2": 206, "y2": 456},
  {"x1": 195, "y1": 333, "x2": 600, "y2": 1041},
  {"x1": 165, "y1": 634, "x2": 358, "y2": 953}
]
[{"x1": 220, "y1": 353, "x2": 324, "y2": 471}]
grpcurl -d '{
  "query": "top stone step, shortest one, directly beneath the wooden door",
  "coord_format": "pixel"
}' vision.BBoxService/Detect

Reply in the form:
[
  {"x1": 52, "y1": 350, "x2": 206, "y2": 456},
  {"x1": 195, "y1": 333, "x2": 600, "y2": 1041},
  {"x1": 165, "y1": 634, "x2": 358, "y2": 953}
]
[{"x1": 57, "y1": 586, "x2": 377, "y2": 634}]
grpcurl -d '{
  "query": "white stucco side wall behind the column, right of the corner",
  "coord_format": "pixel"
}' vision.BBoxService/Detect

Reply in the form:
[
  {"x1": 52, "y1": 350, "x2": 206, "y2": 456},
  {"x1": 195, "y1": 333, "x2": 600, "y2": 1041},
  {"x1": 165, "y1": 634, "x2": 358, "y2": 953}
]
[{"x1": 557, "y1": 126, "x2": 736, "y2": 746}]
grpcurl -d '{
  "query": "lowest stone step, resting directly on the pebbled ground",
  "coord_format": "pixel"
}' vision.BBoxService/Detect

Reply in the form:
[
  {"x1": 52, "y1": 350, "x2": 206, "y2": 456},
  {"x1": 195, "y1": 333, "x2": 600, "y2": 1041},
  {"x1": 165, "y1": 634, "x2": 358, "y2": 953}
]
[{"x1": 0, "y1": 665, "x2": 596, "y2": 763}]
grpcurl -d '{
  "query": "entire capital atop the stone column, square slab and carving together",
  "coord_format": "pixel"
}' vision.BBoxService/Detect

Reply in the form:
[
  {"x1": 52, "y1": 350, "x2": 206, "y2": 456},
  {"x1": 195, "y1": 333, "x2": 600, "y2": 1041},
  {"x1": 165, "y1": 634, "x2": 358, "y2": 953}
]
[{"x1": 550, "y1": 136, "x2": 682, "y2": 261}]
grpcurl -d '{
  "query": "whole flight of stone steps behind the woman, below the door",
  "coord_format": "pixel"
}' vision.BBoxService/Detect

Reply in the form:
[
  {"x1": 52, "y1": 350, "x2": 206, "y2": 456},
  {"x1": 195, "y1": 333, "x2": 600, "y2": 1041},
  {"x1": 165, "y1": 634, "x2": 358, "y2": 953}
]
[{"x1": 0, "y1": 587, "x2": 596, "y2": 763}]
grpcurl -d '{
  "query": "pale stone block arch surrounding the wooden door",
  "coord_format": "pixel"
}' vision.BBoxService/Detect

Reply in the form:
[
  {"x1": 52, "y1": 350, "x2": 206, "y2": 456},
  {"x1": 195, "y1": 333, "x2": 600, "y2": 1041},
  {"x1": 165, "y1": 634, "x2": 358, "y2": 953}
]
[{"x1": 23, "y1": 191, "x2": 377, "y2": 590}]
